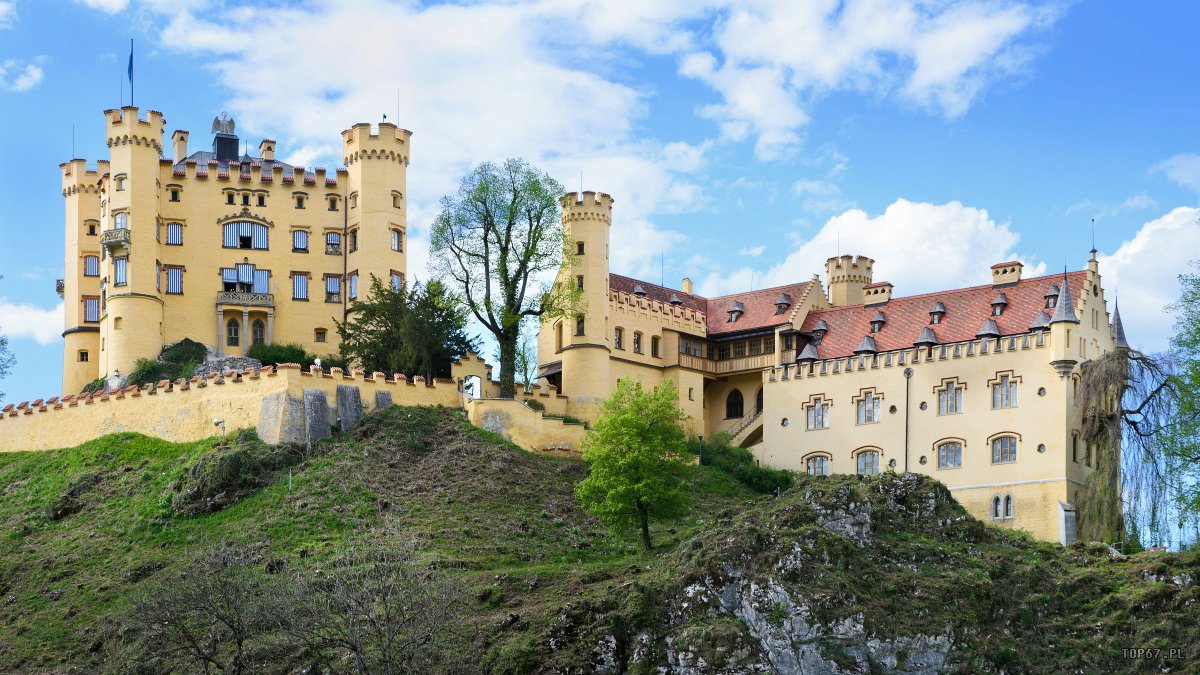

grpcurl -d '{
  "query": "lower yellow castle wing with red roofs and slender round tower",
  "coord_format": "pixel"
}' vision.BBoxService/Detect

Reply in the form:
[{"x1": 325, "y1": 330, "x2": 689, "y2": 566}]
[{"x1": 538, "y1": 192, "x2": 1124, "y2": 543}]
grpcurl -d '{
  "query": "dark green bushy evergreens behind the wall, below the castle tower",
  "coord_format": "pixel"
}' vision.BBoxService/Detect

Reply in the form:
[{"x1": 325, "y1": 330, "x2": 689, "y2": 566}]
[{"x1": 335, "y1": 275, "x2": 474, "y2": 378}]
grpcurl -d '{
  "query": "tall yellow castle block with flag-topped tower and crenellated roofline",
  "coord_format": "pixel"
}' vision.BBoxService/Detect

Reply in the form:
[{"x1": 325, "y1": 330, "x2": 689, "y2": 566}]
[{"x1": 61, "y1": 107, "x2": 412, "y2": 393}]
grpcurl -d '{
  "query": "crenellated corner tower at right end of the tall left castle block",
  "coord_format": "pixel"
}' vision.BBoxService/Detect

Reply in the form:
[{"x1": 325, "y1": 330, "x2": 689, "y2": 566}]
[{"x1": 342, "y1": 123, "x2": 413, "y2": 298}]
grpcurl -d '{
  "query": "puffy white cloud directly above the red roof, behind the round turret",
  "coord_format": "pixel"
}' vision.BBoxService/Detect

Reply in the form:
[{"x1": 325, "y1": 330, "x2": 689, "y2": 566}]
[{"x1": 704, "y1": 199, "x2": 1045, "y2": 297}]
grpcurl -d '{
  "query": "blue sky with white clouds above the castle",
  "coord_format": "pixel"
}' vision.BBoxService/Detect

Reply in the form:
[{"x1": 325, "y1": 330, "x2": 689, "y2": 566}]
[{"x1": 0, "y1": 0, "x2": 1200, "y2": 401}]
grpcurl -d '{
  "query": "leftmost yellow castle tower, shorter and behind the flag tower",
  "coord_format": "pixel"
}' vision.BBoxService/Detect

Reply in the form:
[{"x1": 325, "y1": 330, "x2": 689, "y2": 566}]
[{"x1": 59, "y1": 159, "x2": 108, "y2": 394}]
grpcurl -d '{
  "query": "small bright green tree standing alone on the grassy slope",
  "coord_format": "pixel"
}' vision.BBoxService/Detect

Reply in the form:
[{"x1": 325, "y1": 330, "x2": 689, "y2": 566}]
[{"x1": 575, "y1": 380, "x2": 691, "y2": 550}]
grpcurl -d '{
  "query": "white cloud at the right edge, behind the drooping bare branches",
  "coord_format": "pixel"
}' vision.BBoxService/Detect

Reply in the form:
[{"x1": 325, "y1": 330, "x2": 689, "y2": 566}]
[{"x1": 1099, "y1": 207, "x2": 1200, "y2": 352}]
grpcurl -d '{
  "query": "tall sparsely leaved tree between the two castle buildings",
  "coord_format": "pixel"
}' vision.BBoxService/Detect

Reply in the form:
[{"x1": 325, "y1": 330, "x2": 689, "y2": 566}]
[{"x1": 430, "y1": 159, "x2": 581, "y2": 398}]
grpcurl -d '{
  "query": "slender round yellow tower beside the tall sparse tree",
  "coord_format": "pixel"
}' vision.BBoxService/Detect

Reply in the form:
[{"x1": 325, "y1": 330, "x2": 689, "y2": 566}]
[{"x1": 556, "y1": 192, "x2": 612, "y2": 418}]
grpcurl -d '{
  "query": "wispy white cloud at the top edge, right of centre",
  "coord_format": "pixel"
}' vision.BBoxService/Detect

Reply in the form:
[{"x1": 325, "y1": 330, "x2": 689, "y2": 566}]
[{"x1": 679, "y1": 0, "x2": 1057, "y2": 159}]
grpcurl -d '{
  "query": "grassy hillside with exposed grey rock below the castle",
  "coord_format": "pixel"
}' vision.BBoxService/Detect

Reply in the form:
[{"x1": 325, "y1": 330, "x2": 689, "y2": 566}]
[{"x1": 0, "y1": 407, "x2": 1200, "y2": 673}]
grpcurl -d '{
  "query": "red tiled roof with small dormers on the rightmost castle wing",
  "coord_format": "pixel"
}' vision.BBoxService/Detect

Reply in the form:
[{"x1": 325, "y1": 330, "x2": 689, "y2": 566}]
[{"x1": 796, "y1": 270, "x2": 1087, "y2": 359}]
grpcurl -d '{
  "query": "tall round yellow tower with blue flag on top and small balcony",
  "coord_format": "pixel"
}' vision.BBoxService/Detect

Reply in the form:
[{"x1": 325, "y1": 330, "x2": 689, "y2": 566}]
[{"x1": 98, "y1": 106, "x2": 166, "y2": 375}]
